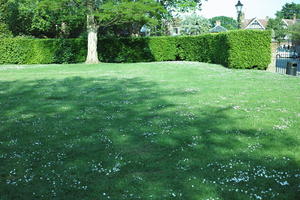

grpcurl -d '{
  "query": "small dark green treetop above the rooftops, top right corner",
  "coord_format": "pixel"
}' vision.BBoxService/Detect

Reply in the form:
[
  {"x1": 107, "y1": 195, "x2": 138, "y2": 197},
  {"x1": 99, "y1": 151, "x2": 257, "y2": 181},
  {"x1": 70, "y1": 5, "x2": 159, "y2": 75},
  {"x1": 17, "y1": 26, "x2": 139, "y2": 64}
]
[{"x1": 276, "y1": 3, "x2": 300, "y2": 19}]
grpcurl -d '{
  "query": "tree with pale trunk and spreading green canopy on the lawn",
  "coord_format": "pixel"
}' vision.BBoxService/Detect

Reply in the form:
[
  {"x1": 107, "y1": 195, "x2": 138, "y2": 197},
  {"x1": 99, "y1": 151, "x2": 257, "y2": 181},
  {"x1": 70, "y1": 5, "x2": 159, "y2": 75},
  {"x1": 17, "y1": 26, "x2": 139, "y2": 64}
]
[{"x1": 40, "y1": 0, "x2": 206, "y2": 64}]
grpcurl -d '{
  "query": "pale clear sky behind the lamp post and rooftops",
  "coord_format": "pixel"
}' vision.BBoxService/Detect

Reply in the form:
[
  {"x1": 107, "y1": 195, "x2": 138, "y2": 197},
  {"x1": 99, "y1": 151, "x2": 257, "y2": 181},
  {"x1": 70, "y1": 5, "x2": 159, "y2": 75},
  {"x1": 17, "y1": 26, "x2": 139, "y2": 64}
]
[{"x1": 199, "y1": 0, "x2": 300, "y2": 19}]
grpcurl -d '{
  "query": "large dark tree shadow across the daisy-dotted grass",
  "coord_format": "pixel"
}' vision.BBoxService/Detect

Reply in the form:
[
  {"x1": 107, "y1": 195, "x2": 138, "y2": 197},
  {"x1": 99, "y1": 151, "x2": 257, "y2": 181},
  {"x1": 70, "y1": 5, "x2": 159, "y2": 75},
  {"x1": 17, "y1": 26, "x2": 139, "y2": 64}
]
[{"x1": 0, "y1": 77, "x2": 300, "y2": 200}]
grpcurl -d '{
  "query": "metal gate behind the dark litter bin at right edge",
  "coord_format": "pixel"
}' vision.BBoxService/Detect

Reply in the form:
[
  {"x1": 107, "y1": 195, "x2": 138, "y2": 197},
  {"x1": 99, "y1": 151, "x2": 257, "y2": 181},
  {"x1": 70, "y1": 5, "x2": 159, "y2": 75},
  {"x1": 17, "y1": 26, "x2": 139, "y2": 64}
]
[{"x1": 276, "y1": 45, "x2": 300, "y2": 76}]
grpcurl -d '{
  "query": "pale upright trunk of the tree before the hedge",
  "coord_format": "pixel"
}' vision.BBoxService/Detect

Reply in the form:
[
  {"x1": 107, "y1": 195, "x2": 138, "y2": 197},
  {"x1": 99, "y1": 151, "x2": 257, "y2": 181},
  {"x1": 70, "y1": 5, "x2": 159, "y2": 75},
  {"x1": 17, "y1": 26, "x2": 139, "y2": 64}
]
[{"x1": 85, "y1": 1, "x2": 99, "y2": 64}]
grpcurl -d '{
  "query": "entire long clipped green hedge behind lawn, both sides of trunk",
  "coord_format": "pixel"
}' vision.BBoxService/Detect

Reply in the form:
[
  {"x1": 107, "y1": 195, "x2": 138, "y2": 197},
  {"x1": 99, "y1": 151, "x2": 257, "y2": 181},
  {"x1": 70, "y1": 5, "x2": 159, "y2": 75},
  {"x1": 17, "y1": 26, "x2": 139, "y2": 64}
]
[{"x1": 0, "y1": 30, "x2": 271, "y2": 69}]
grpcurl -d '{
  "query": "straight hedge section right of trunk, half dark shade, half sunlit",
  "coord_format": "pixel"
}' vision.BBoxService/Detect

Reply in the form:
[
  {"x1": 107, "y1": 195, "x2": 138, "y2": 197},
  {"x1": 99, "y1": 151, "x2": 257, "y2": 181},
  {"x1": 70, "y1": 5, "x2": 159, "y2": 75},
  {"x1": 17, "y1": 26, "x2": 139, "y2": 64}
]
[{"x1": 98, "y1": 37, "x2": 176, "y2": 62}]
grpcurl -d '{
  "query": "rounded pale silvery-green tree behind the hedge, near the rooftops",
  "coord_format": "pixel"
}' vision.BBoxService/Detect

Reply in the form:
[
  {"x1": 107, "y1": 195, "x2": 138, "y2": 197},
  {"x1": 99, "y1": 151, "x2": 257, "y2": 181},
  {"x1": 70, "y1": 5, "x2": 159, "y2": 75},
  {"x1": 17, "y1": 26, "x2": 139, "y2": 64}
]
[{"x1": 180, "y1": 13, "x2": 211, "y2": 35}]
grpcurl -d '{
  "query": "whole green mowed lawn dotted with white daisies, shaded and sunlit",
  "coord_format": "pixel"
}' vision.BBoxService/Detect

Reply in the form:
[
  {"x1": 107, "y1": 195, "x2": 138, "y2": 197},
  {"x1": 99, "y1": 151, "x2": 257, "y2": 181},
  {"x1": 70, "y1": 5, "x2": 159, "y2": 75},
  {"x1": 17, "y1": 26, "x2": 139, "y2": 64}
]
[{"x1": 0, "y1": 62, "x2": 300, "y2": 200}]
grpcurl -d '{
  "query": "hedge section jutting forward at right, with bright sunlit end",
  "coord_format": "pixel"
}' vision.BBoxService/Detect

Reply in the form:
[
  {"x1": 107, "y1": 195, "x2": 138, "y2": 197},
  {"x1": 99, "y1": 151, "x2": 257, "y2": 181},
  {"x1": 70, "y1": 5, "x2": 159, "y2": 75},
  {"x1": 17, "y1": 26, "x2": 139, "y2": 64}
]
[{"x1": 177, "y1": 30, "x2": 271, "y2": 69}]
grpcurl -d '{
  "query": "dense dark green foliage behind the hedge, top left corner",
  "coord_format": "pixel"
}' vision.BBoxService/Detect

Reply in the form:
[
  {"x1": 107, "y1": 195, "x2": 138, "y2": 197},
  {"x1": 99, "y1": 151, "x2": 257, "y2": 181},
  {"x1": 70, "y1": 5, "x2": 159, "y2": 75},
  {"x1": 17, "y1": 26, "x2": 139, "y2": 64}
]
[{"x1": 0, "y1": 0, "x2": 85, "y2": 38}]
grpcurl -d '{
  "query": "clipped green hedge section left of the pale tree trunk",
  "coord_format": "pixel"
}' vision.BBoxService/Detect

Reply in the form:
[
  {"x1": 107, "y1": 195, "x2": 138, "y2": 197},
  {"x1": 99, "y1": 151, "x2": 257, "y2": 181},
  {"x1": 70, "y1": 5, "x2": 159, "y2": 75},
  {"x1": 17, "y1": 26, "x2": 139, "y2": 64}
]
[{"x1": 0, "y1": 38, "x2": 86, "y2": 64}]
